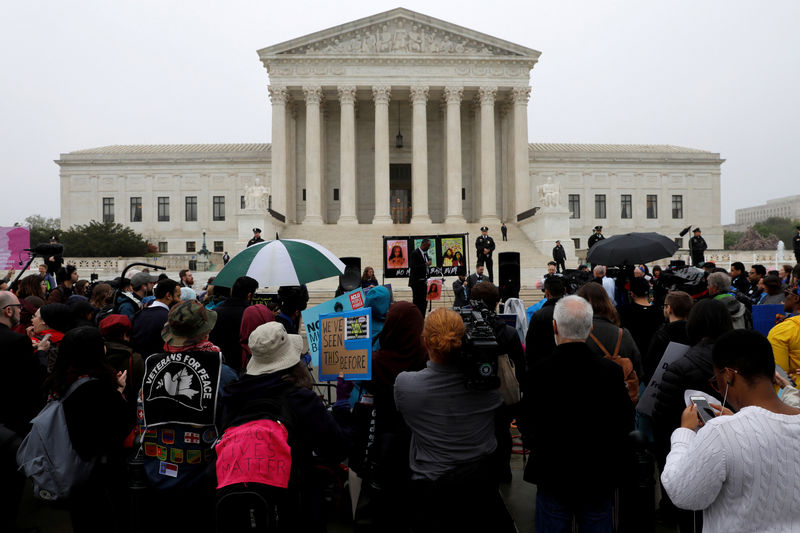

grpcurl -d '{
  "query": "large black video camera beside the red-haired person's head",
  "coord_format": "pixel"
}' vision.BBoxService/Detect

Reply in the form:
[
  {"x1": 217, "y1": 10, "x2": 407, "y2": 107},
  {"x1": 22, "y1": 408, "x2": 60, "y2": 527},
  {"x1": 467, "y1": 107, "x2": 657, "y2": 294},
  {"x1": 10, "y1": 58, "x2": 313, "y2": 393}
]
[{"x1": 454, "y1": 300, "x2": 500, "y2": 390}]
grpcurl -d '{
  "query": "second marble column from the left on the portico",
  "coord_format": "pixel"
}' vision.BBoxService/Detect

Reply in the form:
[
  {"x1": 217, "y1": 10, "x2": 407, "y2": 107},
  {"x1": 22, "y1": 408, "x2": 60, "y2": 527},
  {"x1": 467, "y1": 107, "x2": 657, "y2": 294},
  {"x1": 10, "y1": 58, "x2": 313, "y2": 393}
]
[{"x1": 303, "y1": 87, "x2": 322, "y2": 224}]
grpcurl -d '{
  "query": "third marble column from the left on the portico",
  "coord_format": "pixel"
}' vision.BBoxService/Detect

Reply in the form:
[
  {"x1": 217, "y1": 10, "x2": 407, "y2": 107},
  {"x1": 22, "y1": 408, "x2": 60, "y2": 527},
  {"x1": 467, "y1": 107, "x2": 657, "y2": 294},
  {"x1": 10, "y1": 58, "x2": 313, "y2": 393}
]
[{"x1": 338, "y1": 86, "x2": 358, "y2": 224}]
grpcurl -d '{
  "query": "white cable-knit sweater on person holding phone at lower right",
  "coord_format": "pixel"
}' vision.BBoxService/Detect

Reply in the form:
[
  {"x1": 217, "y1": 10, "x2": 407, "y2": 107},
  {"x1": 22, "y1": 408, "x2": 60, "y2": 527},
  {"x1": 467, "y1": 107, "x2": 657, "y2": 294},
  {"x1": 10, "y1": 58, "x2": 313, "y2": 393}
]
[{"x1": 661, "y1": 407, "x2": 800, "y2": 533}]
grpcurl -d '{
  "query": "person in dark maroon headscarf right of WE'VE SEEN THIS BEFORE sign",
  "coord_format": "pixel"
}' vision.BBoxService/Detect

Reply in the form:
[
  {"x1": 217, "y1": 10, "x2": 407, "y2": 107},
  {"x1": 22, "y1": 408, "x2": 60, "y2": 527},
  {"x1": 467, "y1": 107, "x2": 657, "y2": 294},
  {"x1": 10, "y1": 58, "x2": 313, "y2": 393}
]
[{"x1": 349, "y1": 302, "x2": 428, "y2": 532}]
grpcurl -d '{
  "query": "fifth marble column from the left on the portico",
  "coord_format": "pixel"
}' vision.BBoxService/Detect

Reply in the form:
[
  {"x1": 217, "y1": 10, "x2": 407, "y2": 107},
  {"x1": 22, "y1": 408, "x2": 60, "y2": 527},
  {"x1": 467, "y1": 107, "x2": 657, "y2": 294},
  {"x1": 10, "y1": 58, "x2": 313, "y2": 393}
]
[{"x1": 411, "y1": 85, "x2": 431, "y2": 224}]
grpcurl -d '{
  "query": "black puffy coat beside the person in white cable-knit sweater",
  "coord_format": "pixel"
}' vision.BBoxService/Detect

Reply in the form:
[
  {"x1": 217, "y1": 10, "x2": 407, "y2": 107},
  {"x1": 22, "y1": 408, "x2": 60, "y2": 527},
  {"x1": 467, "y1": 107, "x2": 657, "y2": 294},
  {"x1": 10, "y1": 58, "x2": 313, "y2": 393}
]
[{"x1": 653, "y1": 341, "x2": 718, "y2": 459}]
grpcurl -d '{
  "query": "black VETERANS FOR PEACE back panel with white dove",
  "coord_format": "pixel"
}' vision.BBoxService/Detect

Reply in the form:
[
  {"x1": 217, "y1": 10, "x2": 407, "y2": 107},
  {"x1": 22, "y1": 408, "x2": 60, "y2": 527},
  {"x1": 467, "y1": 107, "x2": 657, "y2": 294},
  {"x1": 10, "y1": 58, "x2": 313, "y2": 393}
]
[{"x1": 142, "y1": 352, "x2": 222, "y2": 427}]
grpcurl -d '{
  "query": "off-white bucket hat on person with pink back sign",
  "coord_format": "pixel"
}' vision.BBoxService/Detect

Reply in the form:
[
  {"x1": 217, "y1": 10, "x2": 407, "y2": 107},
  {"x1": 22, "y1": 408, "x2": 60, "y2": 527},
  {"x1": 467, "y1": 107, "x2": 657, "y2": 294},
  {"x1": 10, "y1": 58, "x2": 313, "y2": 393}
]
[{"x1": 247, "y1": 322, "x2": 303, "y2": 376}]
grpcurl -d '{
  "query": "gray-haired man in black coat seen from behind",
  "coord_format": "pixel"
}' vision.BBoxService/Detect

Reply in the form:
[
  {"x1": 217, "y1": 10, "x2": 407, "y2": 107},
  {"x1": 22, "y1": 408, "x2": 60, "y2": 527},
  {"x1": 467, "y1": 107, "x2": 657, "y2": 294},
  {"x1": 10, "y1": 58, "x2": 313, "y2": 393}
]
[{"x1": 517, "y1": 296, "x2": 633, "y2": 531}]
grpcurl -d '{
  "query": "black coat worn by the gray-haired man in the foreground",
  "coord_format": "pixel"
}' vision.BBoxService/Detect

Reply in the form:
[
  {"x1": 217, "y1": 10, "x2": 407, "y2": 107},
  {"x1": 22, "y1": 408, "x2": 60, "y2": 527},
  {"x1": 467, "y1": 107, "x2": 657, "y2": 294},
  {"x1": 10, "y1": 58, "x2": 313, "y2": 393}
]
[{"x1": 517, "y1": 342, "x2": 633, "y2": 502}]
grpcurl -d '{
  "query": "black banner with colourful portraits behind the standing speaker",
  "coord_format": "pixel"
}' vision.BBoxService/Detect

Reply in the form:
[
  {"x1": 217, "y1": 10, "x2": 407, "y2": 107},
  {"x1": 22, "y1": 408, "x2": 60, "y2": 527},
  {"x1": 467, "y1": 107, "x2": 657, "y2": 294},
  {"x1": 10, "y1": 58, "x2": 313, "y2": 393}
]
[{"x1": 383, "y1": 233, "x2": 469, "y2": 278}]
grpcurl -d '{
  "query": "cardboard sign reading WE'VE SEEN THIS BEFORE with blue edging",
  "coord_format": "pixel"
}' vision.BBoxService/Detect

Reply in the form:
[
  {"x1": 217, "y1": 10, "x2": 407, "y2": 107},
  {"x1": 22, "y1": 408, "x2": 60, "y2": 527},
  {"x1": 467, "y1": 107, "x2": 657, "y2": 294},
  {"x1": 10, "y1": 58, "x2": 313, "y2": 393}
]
[{"x1": 319, "y1": 307, "x2": 372, "y2": 381}]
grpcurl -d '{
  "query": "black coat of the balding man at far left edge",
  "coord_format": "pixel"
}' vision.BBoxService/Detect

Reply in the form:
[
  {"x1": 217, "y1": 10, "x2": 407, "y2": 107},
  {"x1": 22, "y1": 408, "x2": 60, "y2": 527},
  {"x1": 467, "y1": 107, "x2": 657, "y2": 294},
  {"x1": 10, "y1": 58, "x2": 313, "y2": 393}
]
[{"x1": 0, "y1": 324, "x2": 45, "y2": 436}]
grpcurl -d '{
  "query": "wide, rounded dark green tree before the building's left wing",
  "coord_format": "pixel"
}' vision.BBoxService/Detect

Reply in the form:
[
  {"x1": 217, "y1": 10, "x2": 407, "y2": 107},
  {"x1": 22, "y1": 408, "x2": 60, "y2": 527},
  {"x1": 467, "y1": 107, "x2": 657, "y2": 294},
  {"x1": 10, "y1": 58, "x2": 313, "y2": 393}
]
[{"x1": 61, "y1": 220, "x2": 149, "y2": 257}]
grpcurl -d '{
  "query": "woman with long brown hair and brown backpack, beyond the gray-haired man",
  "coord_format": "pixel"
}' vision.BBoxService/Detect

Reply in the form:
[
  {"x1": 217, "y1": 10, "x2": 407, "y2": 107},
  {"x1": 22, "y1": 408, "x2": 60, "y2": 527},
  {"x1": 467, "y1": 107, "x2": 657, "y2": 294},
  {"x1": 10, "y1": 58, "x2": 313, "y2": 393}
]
[{"x1": 576, "y1": 283, "x2": 645, "y2": 382}]
